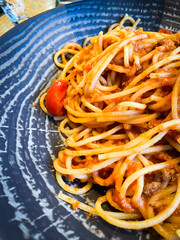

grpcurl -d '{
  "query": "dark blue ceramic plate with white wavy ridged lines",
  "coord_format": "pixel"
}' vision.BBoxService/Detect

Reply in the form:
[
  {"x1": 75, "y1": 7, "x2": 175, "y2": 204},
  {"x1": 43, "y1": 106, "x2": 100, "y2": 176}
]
[{"x1": 0, "y1": 0, "x2": 180, "y2": 240}]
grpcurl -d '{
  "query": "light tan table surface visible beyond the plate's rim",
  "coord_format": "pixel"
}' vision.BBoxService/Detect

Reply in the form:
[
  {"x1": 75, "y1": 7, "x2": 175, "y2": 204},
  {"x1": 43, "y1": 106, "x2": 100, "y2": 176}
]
[{"x1": 0, "y1": 0, "x2": 77, "y2": 36}]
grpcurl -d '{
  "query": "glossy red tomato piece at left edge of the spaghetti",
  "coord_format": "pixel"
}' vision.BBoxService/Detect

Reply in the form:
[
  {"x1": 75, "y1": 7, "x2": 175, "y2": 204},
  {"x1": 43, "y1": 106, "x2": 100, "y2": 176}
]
[{"x1": 46, "y1": 80, "x2": 67, "y2": 116}]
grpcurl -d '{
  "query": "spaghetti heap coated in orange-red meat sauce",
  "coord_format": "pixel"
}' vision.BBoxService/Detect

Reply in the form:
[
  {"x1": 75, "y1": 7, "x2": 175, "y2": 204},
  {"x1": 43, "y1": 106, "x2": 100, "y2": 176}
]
[{"x1": 40, "y1": 15, "x2": 180, "y2": 240}]
